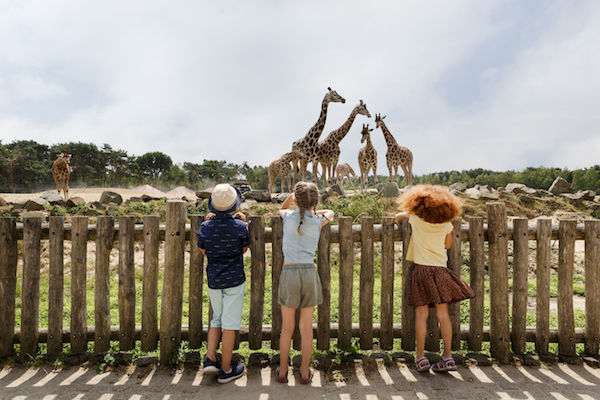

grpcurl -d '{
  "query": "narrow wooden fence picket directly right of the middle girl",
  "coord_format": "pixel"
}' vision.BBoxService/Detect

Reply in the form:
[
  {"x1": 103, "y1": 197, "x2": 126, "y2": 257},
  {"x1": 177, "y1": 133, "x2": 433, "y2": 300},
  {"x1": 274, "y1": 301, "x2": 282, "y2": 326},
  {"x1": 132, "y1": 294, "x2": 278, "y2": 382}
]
[{"x1": 317, "y1": 224, "x2": 331, "y2": 350}]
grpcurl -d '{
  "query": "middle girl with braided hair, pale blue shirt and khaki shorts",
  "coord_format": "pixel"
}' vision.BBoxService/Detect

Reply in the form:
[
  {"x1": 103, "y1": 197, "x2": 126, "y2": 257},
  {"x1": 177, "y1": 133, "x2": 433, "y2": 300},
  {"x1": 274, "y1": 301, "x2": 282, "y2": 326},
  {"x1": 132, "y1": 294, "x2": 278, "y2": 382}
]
[{"x1": 277, "y1": 182, "x2": 334, "y2": 384}]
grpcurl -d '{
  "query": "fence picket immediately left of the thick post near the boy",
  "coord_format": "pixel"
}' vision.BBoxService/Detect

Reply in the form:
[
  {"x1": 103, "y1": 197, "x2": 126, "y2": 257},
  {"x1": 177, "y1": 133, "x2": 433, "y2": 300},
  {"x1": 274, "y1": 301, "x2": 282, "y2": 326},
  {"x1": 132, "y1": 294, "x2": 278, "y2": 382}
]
[{"x1": 142, "y1": 215, "x2": 160, "y2": 351}]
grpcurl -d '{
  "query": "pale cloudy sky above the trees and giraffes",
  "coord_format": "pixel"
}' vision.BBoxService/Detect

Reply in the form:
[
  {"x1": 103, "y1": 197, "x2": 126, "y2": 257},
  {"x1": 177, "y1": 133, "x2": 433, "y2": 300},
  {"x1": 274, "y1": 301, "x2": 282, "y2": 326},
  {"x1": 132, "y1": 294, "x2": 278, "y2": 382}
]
[{"x1": 0, "y1": 0, "x2": 600, "y2": 175}]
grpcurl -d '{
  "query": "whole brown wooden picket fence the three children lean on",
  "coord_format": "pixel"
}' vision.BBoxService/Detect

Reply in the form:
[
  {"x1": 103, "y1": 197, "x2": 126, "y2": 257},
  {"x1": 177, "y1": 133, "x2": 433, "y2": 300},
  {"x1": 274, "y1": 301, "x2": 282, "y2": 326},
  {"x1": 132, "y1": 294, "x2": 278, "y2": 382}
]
[{"x1": 0, "y1": 201, "x2": 600, "y2": 363}]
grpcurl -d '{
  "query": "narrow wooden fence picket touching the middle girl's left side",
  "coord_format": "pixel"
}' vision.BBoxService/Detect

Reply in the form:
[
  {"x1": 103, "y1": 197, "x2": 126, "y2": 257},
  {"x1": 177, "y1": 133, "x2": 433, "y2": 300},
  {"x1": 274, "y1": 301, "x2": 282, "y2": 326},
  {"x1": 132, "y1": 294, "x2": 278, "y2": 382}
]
[{"x1": 271, "y1": 215, "x2": 283, "y2": 350}]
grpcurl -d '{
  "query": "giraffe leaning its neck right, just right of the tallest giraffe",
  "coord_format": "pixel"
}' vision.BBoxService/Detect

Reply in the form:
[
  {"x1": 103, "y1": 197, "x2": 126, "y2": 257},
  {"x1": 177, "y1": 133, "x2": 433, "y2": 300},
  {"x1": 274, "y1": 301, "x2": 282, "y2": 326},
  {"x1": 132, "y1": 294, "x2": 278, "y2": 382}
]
[{"x1": 318, "y1": 100, "x2": 371, "y2": 184}]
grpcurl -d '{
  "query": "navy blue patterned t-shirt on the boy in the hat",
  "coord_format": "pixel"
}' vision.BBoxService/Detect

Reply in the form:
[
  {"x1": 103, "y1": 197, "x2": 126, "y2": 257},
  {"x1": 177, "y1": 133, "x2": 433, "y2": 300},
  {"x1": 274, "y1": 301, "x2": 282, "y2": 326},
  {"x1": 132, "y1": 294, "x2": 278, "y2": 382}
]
[{"x1": 198, "y1": 213, "x2": 250, "y2": 289}]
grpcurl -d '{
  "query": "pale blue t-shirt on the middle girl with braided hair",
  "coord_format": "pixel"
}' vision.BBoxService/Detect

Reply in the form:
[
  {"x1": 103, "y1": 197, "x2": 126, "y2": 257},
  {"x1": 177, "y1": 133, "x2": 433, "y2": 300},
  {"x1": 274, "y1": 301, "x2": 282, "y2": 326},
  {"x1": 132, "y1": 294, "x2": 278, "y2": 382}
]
[{"x1": 282, "y1": 209, "x2": 323, "y2": 264}]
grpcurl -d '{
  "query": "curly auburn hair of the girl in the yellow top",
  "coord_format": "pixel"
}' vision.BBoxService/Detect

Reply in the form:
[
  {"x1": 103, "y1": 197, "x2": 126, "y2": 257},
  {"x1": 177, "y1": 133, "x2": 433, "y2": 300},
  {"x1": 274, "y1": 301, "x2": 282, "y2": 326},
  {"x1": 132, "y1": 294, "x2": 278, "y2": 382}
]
[{"x1": 400, "y1": 185, "x2": 462, "y2": 224}]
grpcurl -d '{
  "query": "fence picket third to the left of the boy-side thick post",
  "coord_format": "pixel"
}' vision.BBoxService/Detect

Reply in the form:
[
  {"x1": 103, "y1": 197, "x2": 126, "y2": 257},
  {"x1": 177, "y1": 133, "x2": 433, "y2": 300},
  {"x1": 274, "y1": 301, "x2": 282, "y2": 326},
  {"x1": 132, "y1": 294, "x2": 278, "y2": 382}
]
[{"x1": 94, "y1": 215, "x2": 115, "y2": 353}]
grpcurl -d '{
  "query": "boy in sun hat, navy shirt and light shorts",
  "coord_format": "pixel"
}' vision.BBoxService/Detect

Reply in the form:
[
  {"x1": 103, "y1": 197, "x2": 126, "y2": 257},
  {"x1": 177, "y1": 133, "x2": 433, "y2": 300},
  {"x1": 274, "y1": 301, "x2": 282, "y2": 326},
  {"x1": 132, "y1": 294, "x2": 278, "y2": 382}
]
[{"x1": 198, "y1": 183, "x2": 250, "y2": 383}]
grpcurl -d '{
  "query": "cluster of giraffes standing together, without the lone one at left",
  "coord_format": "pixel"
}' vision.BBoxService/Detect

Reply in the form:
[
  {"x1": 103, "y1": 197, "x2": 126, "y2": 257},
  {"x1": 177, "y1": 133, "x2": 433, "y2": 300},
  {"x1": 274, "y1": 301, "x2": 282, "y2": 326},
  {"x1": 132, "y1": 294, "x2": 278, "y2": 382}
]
[{"x1": 268, "y1": 88, "x2": 413, "y2": 192}]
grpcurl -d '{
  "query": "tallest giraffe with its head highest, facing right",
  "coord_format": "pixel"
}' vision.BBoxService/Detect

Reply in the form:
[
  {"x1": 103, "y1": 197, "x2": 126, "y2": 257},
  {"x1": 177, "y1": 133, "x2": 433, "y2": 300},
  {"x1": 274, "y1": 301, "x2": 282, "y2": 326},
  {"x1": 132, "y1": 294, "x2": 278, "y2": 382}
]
[{"x1": 292, "y1": 87, "x2": 346, "y2": 183}]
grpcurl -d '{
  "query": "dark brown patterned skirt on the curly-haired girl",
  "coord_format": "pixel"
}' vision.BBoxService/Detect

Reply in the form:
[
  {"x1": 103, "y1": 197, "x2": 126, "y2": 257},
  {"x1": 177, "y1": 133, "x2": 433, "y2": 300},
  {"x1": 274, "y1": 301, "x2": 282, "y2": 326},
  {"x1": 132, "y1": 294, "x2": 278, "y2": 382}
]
[{"x1": 408, "y1": 264, "x2": 475, "y2": 307}]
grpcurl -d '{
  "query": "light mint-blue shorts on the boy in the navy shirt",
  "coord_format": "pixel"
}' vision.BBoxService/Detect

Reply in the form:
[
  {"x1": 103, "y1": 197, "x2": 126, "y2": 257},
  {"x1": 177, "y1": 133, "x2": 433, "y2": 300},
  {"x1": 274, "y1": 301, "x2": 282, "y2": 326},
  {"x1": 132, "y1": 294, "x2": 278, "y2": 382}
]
[{"x1": 208, "y1": 282, "x2": 246, "y2": 331}]
